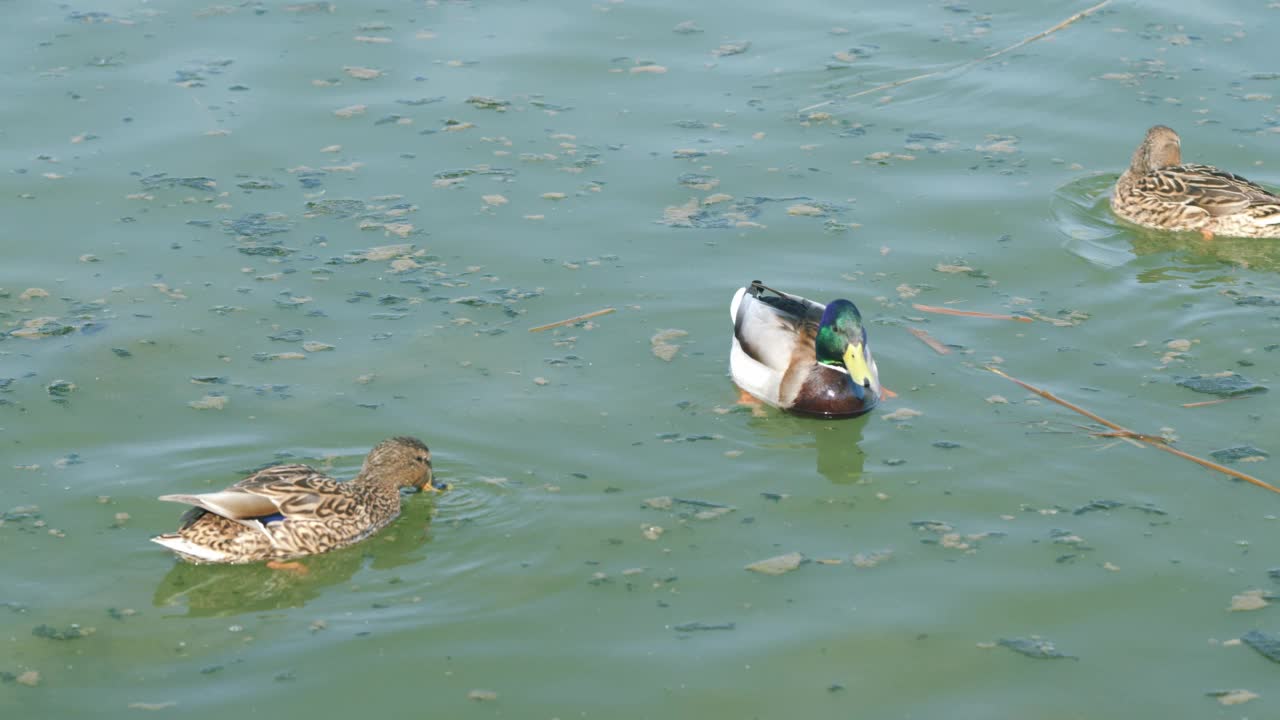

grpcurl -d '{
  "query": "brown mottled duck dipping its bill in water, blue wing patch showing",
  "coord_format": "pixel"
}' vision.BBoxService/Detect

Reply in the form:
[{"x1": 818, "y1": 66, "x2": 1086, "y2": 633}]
[{"x1": 151, "y1": 437, "x2": 439, "y2": 564}]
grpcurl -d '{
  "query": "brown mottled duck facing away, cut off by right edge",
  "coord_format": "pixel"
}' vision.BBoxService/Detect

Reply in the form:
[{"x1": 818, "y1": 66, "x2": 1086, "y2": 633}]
[{"x1": 1111, "y1": 126, "x2": 1280, "y2": 237}]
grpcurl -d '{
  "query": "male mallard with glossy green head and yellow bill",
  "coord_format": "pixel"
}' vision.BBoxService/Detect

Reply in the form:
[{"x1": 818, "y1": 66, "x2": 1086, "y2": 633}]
[{"x1": 728, "y1": 281, "x2": 881, "y2": 418}]
